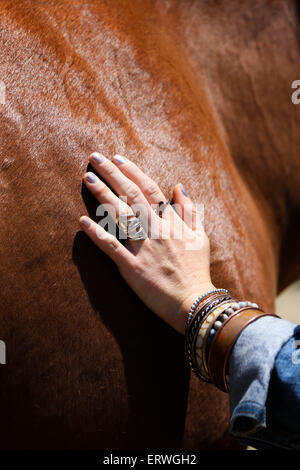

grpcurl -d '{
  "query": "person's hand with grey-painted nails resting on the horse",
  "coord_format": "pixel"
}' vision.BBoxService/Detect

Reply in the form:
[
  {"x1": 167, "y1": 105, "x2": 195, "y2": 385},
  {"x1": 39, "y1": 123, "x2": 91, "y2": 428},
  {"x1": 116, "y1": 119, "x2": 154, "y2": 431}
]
[{"x1": 80, "y1": 152, "x2": 214, "y2": 333}]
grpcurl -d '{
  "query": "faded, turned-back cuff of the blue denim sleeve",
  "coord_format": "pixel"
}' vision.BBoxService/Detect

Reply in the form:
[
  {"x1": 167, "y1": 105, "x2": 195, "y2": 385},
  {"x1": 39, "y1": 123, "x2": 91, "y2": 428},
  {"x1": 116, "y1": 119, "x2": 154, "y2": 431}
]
[{"x1": 229, "y1": 316, "x2": 296, "y2": 438}]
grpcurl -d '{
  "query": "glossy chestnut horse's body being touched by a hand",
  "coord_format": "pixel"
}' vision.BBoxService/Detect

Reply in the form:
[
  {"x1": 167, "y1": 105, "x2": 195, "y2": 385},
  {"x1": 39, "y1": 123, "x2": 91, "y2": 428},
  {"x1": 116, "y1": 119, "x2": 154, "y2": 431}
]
[{"x1": 0, "y1": 0, "x2": 300, "y2": 449}]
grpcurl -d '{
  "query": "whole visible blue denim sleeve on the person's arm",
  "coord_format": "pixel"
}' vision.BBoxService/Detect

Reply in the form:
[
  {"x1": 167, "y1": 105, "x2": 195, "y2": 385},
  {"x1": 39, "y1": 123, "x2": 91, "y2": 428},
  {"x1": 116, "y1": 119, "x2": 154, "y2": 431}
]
[{"x1": 229, "y1": 317, "x2": 300, "y2": 450}]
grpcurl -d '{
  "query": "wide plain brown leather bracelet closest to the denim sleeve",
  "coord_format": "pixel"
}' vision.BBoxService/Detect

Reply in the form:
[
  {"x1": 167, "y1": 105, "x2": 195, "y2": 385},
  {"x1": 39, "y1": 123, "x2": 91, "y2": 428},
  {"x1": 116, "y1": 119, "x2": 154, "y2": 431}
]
[{"x1": 207, "y1": 308, "x2": 280, "y2": 392}]
